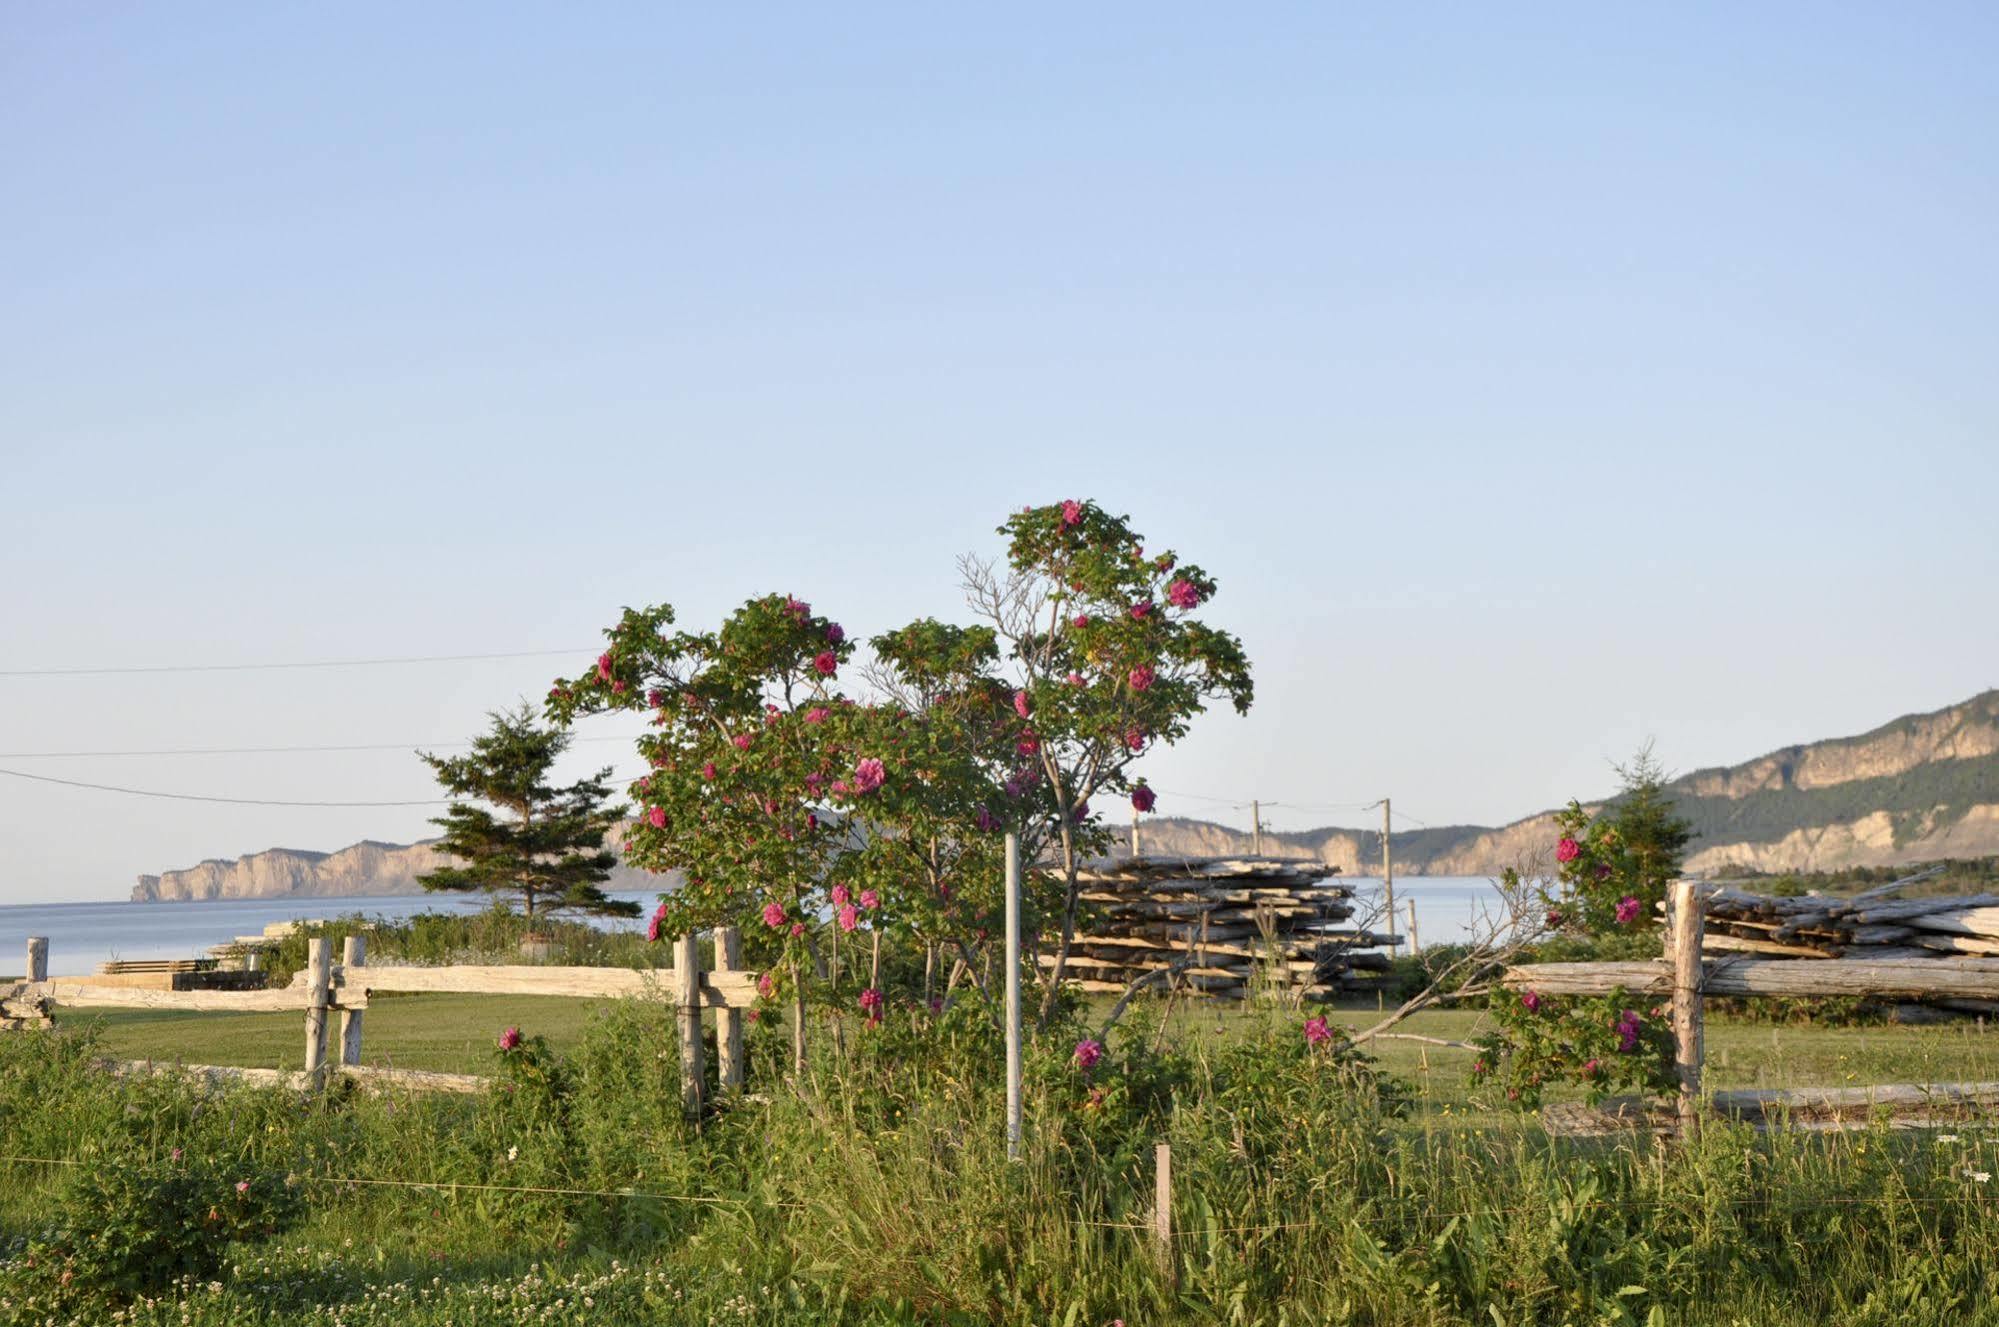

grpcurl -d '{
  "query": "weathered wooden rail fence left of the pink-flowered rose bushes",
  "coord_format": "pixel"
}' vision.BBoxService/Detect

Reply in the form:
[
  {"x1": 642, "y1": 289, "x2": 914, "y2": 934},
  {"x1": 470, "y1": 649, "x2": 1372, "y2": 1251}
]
[{"x1": 0, "y1": 927, "x2": 758, "y2": 1115}]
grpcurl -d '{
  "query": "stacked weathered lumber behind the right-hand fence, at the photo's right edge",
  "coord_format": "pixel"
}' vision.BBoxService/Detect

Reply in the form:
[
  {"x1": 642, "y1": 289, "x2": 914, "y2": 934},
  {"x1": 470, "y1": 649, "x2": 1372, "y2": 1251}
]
[{"x1": 1703, "y1": 887, "x2": 1999, "y2": 959}]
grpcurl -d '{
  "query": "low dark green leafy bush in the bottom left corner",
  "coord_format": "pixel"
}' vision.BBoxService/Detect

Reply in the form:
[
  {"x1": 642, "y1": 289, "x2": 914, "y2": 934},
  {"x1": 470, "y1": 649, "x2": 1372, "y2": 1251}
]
[{"x1": 0, "y1": 1149, "x2": 306, "y2": 1307}]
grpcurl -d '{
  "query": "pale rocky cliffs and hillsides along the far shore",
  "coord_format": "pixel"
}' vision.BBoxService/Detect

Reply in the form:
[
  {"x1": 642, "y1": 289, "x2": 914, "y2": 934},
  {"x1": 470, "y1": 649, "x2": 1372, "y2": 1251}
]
[{"x1": 132, "y1": 691, "x2": 1999, "y2": 901}]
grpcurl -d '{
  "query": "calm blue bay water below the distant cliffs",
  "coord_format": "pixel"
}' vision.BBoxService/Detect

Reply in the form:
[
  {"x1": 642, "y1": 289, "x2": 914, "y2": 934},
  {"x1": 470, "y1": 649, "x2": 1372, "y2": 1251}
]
[{"x1": 0, "y1": 875, "x2": 1493, "y2": 975}]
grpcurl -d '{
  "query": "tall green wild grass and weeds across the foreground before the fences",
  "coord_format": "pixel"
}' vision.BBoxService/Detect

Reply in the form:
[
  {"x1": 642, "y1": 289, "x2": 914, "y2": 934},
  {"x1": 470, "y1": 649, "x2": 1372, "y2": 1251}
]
[{"x1": 0, "y1": 1001, "x2": 1999, "y2": 1327}]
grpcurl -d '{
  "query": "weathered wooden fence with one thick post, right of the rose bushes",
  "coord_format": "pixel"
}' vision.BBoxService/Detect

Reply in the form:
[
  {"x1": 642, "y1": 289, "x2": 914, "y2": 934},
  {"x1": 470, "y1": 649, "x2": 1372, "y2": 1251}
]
[{"x1": 1503, "y1": 879, "x2": 1999, "y2": 1123}]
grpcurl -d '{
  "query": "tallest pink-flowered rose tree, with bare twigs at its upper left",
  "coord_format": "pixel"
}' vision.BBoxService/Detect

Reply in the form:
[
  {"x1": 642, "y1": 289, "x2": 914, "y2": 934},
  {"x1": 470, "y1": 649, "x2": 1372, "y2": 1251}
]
[{"x1": 962, "y1": 500, "x2": 1253, "y2": 1023}]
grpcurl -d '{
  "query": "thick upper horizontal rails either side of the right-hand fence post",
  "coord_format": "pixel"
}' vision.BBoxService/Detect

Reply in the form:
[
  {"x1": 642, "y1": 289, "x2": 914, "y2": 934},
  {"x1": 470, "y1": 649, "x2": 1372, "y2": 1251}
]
[{"x1": 1503, "y1": 959, "x2": 1999, "y2": 999}]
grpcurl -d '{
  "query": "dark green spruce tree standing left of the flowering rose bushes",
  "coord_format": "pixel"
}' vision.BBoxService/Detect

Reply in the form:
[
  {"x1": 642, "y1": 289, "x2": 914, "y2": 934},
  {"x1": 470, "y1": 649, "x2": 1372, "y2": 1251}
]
[{"x1": 418, "y1": 701, "x2": 640, "y2": 921}]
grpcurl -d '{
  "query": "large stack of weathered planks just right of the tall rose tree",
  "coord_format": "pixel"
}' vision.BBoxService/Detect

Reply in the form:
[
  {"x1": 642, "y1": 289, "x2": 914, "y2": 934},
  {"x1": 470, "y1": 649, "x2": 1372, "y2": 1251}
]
[{"x1": 1041, "y1": 857, "x2": 1399, "y2": 997}]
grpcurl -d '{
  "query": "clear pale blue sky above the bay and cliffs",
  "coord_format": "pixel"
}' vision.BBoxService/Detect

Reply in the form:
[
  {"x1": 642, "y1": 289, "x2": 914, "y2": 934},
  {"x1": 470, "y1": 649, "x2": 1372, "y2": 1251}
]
[{"x1": 0, "y1": 4, "x2": 1999, "y2": 901}]
